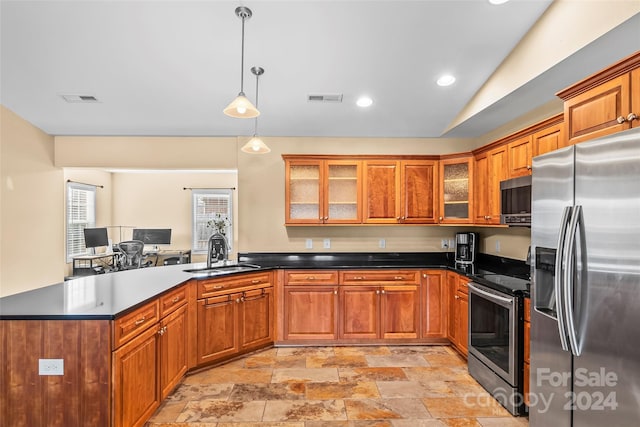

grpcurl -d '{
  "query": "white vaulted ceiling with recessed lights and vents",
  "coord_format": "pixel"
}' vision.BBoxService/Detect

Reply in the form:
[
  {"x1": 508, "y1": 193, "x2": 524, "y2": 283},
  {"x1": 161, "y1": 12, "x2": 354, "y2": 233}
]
[{"x1": 0, "y1": 0, "x2": 638, "y2": 137}]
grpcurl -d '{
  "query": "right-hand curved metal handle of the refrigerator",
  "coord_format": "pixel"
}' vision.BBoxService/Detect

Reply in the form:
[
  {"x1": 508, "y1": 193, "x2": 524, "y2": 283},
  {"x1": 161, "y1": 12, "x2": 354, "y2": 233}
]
[{"x1": 563, "y1": 205, "x2": 582, "y2": 356}]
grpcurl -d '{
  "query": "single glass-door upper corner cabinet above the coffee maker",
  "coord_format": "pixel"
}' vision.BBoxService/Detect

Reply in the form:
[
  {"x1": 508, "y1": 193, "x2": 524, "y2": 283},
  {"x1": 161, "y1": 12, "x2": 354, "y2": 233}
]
[{"x1": 438, "y1": 153, "x2": 473, "y2": 224}]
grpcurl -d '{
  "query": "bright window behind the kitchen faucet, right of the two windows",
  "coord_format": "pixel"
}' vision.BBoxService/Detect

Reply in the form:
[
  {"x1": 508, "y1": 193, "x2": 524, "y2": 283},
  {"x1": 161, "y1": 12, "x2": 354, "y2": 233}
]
[{"x1": 191, "y1": 190, "x2": 233, "y2": 253}]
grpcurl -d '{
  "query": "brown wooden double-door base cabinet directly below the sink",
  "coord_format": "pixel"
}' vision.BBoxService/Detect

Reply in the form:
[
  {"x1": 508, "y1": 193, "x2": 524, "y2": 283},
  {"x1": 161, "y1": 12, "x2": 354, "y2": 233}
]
[{"x1": 197, "y1": 272, "x2": 274, "y2": 365}]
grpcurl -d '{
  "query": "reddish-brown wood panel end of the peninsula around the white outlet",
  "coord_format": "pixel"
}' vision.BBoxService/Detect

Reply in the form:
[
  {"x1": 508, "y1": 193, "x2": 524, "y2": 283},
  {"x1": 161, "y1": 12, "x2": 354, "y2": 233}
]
[{"x1": 0, "y1": 320, "x2": 111, "y2": 427}]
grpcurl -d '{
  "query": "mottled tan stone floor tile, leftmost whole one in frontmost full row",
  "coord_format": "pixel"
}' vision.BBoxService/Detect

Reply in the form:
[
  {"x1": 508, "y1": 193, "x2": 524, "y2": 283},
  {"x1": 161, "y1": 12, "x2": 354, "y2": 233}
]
[{"x1": 176, "y1": 400, "x2": 265, "y2": 423}]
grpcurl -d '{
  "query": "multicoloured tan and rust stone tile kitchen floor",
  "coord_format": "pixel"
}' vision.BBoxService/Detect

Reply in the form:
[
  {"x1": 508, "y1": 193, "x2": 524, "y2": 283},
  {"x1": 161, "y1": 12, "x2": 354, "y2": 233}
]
[{"x1": 147, "y1": 346, "x2": 528, "y2": 427}]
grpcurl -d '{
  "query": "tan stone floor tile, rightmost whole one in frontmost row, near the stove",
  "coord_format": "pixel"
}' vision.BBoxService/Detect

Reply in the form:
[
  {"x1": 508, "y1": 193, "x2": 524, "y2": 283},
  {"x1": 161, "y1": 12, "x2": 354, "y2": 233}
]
[{"x1": 422, "y1": 397, "x2": 510, "y2": 418}]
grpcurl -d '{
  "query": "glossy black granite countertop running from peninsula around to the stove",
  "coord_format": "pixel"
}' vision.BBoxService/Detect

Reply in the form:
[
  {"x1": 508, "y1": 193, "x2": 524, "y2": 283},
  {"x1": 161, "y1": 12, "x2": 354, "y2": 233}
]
[{"x1": 0, "y1": 252, "x2": 529, "y2": 320}]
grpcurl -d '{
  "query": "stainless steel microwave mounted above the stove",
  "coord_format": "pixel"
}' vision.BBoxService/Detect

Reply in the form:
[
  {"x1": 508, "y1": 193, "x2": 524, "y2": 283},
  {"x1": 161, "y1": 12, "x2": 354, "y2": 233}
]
[{"x1": 500, "y1": 175, "x2": 531, "y2": 227}]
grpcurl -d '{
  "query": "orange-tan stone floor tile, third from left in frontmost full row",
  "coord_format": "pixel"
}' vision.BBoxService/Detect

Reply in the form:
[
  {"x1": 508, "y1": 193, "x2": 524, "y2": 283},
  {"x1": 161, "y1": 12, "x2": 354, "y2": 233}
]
[{"x1": 345, "y1": 399, "x2": 431, "y2": 420}]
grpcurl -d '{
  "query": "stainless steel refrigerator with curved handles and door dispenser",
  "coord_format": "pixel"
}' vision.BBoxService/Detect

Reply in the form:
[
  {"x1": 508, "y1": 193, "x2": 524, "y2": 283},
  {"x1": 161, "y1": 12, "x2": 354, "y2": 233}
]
[{"x1": 529, "y1": 129, "x2": 640, "y2": 427}]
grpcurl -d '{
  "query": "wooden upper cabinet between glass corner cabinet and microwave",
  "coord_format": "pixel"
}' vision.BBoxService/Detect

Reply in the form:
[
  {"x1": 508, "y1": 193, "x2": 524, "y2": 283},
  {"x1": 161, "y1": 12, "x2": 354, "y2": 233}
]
[{"x1": 474, "y1": 145, "x2": 508, "y2": 225}]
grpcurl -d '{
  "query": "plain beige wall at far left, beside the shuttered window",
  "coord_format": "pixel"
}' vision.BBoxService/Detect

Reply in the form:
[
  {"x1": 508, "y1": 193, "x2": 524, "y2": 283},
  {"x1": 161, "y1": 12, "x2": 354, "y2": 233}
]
[{"x1": 0, "y1": 106, "x2": 65, "y2": 296}]
